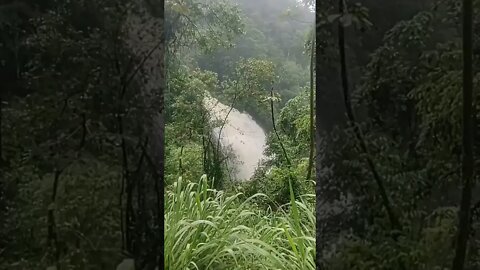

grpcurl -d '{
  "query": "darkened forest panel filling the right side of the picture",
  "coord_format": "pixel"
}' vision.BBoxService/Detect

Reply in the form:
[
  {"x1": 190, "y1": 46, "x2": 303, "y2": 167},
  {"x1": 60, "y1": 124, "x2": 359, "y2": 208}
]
[{"x1": 316, "y1": 0, "x2": 480, "y2": 270}]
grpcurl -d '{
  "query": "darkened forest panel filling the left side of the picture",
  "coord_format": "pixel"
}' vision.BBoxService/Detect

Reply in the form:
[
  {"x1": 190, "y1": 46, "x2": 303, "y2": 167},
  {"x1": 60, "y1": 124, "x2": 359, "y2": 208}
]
[{"x1": 0, "y1": 0, "x2": 164, "y2": 270}]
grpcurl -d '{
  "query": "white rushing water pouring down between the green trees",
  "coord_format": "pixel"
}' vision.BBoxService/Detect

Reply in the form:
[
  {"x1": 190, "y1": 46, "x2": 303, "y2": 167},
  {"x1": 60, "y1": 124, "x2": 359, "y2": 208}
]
[{"x1": 204, "y1": 96, "x2": 266, "y2": 181}]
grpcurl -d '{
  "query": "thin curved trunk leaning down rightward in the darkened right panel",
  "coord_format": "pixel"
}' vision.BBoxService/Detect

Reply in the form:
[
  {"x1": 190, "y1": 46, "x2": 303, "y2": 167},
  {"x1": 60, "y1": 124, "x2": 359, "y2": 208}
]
[{"x1": 338, "y1": 0, "x2": 401, "y2": 229}]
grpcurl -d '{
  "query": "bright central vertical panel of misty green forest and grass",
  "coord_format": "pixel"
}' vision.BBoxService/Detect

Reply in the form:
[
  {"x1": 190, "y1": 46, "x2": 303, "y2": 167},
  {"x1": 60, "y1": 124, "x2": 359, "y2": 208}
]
[{"x1": 165, "y1": 0, "x2": 315, "y2": 270}]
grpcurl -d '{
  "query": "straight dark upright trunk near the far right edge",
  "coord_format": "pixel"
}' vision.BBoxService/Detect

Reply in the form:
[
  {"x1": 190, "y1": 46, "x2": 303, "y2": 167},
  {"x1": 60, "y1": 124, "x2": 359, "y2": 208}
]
[{"x1": 452, "y1": 0, "x2": 474, "y2": 270}]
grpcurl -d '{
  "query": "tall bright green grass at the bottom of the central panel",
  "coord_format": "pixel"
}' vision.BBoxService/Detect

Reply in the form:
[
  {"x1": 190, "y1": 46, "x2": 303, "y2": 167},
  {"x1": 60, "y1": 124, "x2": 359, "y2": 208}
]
[{"x1": 165, "y1": 176, "x2": 315, "y2": 270}]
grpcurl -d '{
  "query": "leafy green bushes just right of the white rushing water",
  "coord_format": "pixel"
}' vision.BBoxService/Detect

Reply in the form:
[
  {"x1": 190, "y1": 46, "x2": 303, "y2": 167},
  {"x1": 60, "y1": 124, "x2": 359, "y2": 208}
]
[{"x1": 237, "y1": 92, "x2": 314, "y2": 207}]
